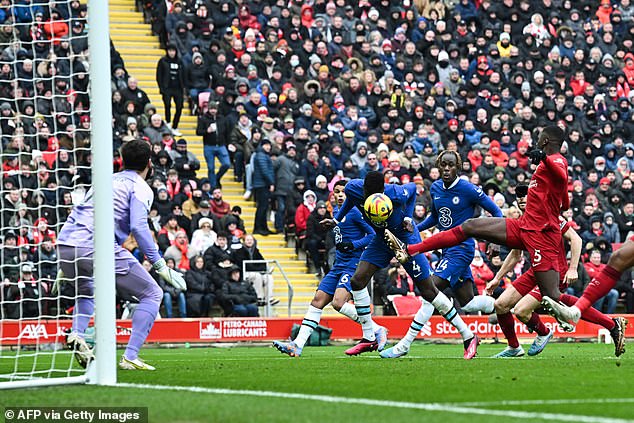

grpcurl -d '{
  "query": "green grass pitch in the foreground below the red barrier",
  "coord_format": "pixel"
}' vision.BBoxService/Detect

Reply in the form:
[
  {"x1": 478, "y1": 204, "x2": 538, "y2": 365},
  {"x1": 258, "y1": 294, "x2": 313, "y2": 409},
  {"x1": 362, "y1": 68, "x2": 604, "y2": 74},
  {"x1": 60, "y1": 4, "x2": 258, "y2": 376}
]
[{"x1": 0, "y1": 343, "x2": 634, "y2": 423}]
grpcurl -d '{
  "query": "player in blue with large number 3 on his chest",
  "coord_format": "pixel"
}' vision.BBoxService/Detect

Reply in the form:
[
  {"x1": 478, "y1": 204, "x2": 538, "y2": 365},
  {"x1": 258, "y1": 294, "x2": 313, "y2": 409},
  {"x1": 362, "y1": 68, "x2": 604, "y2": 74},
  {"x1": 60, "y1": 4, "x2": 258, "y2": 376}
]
[{"x1": 381, "y1": 150, "x2": 502, "y2": 358}]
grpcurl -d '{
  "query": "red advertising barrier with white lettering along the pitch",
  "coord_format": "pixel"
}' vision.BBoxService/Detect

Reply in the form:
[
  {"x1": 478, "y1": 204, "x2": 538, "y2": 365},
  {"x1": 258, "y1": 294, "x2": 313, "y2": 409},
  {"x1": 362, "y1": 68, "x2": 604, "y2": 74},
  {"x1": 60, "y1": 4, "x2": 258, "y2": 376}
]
[{"x1": 0, "y1": 315, "x2": 634, "y2": 346}]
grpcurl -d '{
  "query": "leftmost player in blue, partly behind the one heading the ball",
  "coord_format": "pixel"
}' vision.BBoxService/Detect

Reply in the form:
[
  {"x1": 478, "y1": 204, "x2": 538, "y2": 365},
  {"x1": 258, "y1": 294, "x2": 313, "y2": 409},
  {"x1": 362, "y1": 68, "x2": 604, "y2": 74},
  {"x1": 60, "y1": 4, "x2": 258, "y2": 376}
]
[{"x1": 273, "y1": 180, "x2": 387, "y2": 357}]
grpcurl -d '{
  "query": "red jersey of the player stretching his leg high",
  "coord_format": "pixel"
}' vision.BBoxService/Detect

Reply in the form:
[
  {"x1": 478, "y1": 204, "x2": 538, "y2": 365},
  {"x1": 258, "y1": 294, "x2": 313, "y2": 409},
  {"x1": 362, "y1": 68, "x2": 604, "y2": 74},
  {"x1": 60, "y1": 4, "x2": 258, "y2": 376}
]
[{"x1": 520, "y1": 153, "x2": 570, "y2": 231}]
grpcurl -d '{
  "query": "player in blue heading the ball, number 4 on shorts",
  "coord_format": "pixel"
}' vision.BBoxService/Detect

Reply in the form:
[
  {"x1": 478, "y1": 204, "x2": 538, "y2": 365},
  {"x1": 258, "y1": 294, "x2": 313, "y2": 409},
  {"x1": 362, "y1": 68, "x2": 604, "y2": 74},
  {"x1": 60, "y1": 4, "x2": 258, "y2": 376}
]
[{"x1": 321, "y1": 171, "x2": 479, "y2": 359}]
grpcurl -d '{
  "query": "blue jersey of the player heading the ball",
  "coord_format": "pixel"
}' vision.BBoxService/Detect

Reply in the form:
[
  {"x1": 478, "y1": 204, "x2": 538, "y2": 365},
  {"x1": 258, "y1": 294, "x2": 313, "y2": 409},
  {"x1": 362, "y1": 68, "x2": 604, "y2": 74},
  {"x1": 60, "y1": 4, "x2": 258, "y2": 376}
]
[{"x1": 335, "y1": 179, "x2": 416, "y2": 239}]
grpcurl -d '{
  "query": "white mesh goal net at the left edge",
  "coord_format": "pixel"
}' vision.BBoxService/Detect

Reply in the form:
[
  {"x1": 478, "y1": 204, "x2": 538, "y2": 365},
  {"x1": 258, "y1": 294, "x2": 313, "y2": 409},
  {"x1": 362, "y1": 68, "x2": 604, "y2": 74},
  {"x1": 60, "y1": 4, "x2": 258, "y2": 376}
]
[{"x1": 0, "y1": 0, "x2": 114, "y2": 387}]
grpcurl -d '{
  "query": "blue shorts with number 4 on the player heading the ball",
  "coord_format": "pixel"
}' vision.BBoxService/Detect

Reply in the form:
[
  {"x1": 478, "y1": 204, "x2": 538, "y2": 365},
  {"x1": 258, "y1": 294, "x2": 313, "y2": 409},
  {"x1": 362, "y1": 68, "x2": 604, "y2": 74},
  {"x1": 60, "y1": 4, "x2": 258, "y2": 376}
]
[{"x1": 361, "y1": 231, "x2": 430, "y2": 281}]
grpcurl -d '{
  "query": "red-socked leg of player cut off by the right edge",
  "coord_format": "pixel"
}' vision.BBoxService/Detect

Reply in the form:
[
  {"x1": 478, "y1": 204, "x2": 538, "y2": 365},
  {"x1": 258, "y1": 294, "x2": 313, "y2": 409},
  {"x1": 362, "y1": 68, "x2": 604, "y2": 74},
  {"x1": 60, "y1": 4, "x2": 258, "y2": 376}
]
[{"x1": 542, "y1": 237, "x2": 634, "y2": 344}]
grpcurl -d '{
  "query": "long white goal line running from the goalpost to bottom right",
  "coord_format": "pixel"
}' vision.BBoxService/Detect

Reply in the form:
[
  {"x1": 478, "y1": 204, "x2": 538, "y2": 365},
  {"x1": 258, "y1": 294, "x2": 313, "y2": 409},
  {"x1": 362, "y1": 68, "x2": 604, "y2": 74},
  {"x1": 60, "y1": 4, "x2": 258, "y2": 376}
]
[{"x1": 117, "y1": 383, "x2": 634, "y2": 423}]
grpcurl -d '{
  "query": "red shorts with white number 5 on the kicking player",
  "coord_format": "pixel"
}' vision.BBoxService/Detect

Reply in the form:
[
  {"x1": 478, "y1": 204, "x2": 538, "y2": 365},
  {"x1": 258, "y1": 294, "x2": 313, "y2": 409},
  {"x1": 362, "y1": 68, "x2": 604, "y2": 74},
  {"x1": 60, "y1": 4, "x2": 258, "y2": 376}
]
[{"x1": 506, "y1": 219, "x2": 561, "y2": 272}]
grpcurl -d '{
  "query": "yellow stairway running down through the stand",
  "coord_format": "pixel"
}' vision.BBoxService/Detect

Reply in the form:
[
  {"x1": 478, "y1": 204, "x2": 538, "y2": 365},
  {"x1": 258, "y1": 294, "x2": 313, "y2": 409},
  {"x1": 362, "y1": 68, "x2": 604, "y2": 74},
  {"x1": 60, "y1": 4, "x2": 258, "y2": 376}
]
[{"x1": 109, "y1": 0, "x2": 335, "y2": 318}]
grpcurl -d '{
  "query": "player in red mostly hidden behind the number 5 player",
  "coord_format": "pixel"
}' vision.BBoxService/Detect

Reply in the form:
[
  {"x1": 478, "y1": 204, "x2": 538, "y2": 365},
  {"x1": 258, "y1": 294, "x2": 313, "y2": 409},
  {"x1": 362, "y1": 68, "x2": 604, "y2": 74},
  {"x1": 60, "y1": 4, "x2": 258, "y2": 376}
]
[{"x1": 486, "y1": 185, "x2": 627, "y2": 358}]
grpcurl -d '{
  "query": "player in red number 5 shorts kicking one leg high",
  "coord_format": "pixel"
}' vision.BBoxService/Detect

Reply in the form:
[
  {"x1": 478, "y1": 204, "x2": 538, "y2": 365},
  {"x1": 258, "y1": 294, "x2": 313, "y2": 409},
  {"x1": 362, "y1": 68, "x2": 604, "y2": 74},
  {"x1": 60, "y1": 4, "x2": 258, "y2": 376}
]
[{"x1": 385, "y1": 125, "x2": 570, "y2": 304}]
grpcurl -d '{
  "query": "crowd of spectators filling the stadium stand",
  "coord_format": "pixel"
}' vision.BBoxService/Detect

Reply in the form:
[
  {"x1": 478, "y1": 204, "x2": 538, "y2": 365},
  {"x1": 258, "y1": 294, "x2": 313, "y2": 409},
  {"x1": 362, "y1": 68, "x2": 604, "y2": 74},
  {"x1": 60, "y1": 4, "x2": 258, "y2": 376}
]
[{"x1": 0, "y1": 0, "x2": 634, "y2": 322}]
